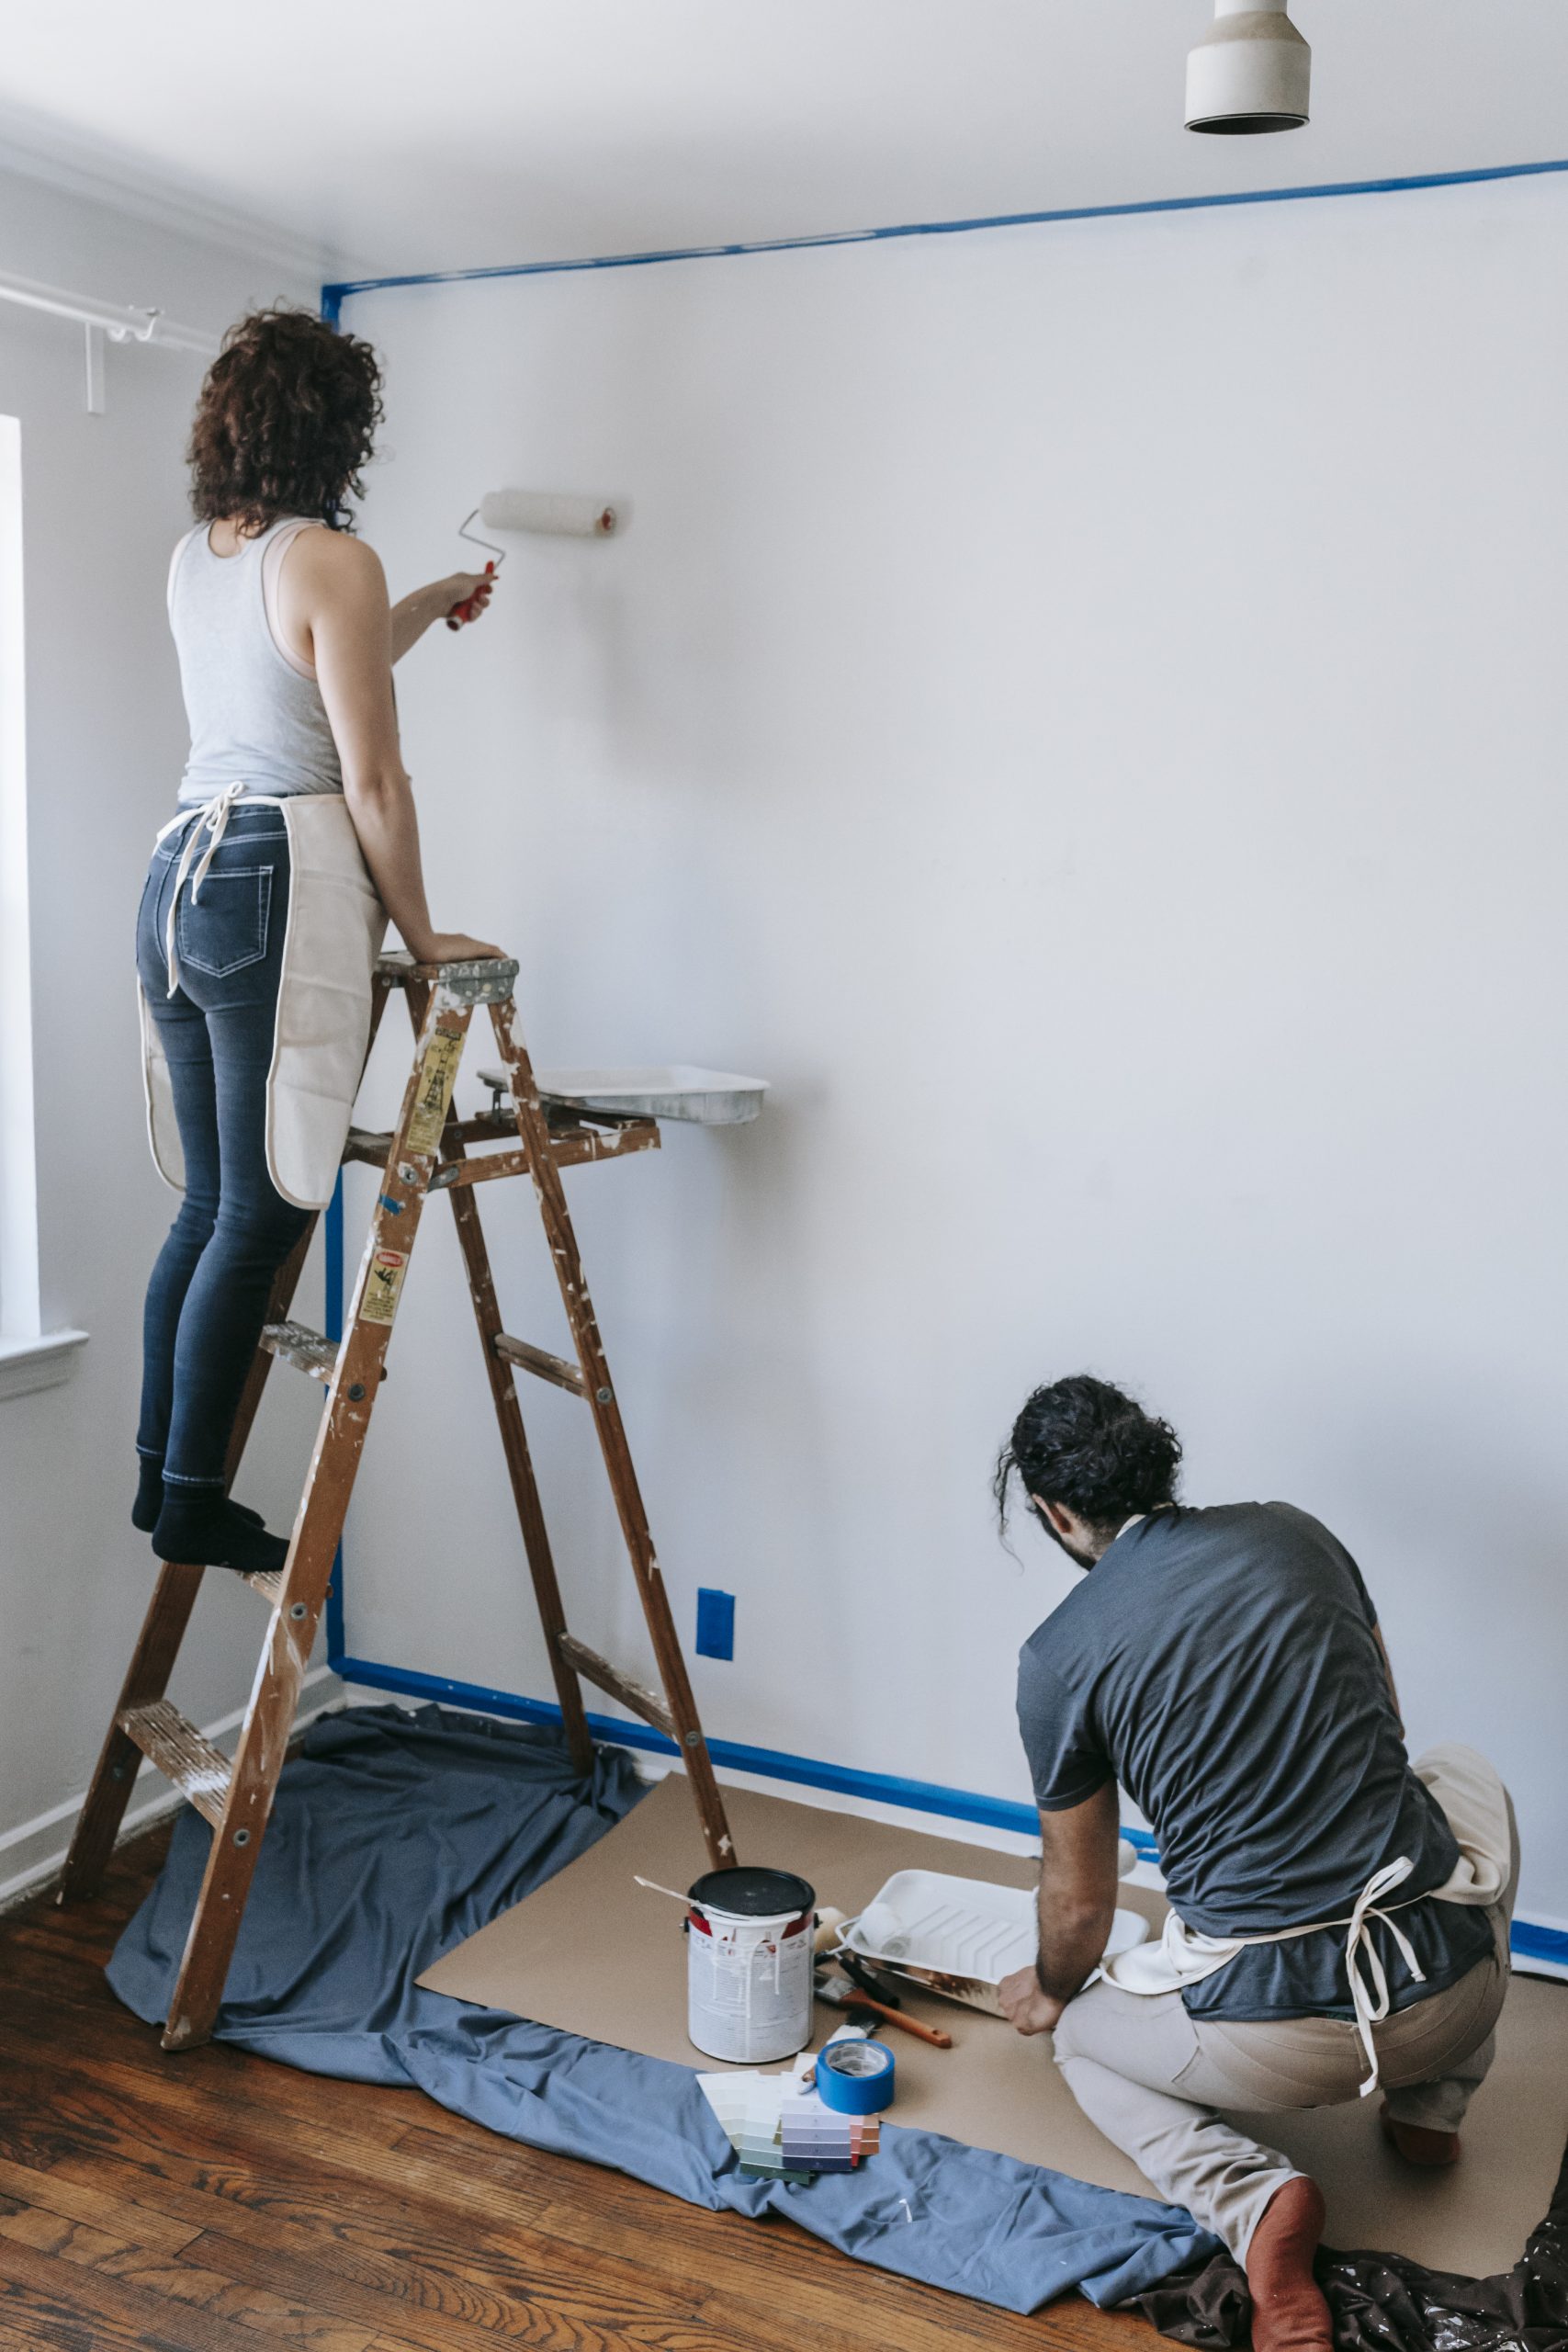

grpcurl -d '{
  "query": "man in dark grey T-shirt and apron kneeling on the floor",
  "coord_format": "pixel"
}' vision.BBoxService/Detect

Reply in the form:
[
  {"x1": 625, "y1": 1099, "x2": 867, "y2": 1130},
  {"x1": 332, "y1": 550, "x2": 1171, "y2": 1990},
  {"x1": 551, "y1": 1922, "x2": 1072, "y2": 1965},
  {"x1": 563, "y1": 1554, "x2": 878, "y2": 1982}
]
[{"x1": 997, "y1": 1376, "x2": 1518, "y2": 2352}]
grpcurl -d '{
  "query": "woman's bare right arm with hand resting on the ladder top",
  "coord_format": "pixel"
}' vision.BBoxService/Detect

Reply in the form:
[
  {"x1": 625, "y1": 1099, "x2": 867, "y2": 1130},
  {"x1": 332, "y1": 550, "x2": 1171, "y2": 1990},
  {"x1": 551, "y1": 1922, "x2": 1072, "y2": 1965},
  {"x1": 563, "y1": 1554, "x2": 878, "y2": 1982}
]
[{"x1": 277, "y1": 532, "x2": 501, "y2": 965}]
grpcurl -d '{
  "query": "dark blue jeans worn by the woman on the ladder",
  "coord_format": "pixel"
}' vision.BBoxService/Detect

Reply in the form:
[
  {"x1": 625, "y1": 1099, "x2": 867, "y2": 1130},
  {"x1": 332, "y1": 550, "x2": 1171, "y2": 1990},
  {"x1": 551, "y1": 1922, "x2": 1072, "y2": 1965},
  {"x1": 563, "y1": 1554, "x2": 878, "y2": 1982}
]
[{"x1": 136, "y1": 807, "x2": 310, "y2": 1498}]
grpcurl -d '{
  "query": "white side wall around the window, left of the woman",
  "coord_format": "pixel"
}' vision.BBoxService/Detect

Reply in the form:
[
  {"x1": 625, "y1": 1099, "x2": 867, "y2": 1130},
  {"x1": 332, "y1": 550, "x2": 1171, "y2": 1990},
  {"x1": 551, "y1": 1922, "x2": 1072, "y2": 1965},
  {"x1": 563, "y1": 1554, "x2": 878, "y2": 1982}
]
[{"x1": 0, "y1": 172, "x2": 331, "y2": 1886}]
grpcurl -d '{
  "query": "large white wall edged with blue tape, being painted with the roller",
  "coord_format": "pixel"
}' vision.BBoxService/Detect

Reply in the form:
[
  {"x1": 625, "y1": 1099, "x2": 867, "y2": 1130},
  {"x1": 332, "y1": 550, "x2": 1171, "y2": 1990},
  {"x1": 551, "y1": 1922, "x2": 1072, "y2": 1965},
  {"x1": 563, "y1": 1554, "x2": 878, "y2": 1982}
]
[{"x1": 345, "y1": 181, "x2": 1568, "y2": 1915}]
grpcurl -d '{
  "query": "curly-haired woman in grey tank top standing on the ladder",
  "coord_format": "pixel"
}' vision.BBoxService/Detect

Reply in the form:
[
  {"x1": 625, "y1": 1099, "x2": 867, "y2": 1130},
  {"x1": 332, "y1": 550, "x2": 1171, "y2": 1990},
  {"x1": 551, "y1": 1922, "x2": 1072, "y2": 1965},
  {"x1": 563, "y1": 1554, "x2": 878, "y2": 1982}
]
[{"x1": 131, "y1": 311, "x2": 501, "y2": 1571}]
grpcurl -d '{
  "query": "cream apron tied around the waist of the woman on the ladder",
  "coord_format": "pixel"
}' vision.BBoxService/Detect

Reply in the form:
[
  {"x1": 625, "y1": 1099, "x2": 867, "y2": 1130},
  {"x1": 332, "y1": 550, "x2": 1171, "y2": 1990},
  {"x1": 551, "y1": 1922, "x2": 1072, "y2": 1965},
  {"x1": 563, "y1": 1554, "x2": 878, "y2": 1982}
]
[{"x1": 141, "y1": 783, "x2": 386, "y2": 1209}]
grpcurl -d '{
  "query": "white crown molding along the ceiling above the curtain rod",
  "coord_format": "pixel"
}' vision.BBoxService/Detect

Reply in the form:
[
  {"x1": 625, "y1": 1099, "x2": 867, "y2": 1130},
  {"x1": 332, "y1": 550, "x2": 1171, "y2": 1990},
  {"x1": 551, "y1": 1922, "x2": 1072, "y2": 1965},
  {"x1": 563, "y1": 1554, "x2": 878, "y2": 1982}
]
[{"x1": 0, "y1": 101, "x2": 368, "y2": 285}]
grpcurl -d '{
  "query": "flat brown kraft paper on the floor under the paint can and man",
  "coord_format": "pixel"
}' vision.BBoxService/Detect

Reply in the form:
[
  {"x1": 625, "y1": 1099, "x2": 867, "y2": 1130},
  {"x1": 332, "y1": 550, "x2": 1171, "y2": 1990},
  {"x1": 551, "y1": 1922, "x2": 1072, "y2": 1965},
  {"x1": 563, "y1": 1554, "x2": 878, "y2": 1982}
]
[{"x1": 419, "y1": 1773, "x2": 1568, "y2": 2277}]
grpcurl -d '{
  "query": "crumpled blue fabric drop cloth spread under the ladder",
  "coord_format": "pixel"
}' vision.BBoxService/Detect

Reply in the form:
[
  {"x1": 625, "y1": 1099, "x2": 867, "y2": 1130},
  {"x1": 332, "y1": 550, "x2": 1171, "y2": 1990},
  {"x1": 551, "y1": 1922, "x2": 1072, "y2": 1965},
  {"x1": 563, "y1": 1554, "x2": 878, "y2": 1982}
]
[{"x1": 108, "y1": 1708, "x2": 1229, "y2": 2304}]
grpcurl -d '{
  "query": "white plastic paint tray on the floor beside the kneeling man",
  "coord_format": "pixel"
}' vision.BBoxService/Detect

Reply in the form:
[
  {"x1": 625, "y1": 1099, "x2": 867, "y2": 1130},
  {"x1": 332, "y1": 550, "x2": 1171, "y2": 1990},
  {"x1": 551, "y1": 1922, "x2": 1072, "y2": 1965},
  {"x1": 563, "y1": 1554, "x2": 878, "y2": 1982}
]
[{"x1": 844, "y1": 1870, "x2": 1149, "y2": 2016}]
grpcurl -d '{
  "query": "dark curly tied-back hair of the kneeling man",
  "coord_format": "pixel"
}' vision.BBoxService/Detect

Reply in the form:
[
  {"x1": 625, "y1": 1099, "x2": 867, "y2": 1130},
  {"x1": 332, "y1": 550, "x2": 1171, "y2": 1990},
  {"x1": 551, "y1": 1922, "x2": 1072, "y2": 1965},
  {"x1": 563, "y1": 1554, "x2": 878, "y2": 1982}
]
[{"x1": 992, "y1": 1371, "x2": 1182, "y2": 1533}]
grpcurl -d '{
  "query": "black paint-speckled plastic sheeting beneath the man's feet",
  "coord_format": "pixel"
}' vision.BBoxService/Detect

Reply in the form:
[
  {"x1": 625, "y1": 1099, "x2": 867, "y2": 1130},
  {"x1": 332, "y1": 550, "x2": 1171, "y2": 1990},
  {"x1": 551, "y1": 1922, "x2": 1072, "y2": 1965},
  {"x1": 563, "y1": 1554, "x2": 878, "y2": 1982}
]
[{"x1": 1128, "y1": 2157, "x2": 1568, "y2": 2352}]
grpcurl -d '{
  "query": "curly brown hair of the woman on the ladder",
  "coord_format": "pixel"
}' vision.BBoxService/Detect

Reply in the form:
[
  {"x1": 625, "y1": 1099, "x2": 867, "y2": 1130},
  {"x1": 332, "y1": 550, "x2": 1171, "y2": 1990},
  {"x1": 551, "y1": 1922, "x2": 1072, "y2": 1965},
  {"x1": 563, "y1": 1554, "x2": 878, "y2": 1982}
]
[{"x1": 186, "y1": 306, "x2": 381, "y2": 537}]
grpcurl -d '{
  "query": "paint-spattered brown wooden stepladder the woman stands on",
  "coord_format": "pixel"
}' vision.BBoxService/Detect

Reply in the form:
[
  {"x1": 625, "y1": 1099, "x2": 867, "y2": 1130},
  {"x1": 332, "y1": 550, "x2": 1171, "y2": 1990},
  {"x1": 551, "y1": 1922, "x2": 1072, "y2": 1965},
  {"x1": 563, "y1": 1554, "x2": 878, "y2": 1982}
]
[{"x1": 59, "y1": 955, "x2": 736, "y2": 2051}]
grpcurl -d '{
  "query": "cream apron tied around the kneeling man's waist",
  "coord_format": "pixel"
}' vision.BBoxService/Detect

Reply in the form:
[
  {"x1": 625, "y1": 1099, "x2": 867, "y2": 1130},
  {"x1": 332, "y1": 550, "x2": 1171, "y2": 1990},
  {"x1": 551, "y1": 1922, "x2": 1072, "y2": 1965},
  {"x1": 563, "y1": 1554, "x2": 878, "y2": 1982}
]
[{"x1": 1100, "y1": 1740, "x2": 1514, "y2": 2098}]
